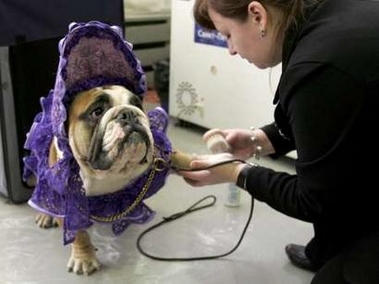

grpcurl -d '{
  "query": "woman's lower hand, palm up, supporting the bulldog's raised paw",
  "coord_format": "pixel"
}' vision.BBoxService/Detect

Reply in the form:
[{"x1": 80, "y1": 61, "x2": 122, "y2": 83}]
[{"x1": 177, "y1": 153, "x2": 245, "y2": 186}]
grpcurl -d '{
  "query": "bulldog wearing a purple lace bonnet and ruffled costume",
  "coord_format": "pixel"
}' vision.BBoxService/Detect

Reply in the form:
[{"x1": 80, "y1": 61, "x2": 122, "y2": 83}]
[{"x1": 23, "y1": 21, "x2": 191, "y2": 275}]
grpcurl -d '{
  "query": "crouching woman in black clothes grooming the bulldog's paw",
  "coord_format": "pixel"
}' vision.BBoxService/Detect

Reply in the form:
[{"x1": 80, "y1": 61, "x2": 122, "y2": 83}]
[{"x1": 180, "y1": 0, "x2": 379, "y2": 284}]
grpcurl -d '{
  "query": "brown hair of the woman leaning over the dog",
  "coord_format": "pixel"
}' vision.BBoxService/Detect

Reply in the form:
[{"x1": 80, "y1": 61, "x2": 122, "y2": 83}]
[{"x1": 193, "y1": 0, "x2": 317, "y2": 34}]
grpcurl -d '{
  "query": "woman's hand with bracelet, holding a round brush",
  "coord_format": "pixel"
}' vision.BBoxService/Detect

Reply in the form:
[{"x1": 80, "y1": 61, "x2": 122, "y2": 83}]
[{"x1": 203, "y1": 128, "x2": 275, "y2": 160}]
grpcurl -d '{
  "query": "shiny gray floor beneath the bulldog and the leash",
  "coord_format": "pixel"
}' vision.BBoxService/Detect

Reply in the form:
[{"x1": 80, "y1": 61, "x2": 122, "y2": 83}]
[{"x1": 0, "y1": 118, "x2": 313, "y2": 284}]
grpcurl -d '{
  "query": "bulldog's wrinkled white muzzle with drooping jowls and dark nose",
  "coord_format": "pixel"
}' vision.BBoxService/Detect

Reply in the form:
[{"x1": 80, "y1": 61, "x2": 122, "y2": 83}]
[{"x1": 88, "y1": 109, "x2": 153, "y2": 171}]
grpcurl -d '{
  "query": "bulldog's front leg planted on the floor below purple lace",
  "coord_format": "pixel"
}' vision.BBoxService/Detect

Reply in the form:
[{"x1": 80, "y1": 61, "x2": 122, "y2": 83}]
[{"x1": 67, "y1": 230, "x2": 101, "y2": 275}]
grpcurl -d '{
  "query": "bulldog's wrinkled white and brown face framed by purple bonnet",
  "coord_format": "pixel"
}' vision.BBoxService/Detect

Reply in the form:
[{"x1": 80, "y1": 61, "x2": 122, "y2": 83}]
[{"x1": 68, "y1": 85, "x2": 154, "y2": 195}]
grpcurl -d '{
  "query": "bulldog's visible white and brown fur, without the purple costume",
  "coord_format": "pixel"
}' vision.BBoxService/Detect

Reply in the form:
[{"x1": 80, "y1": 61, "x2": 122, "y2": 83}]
[{"x1": 29, "y1": 85, "x2": 190, "y2": 275}]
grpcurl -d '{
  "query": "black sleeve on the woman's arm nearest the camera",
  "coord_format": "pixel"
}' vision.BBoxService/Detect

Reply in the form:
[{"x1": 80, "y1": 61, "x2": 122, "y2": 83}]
[{"x1": 239, "y1": 66, "x2": 364, "y2": 222}]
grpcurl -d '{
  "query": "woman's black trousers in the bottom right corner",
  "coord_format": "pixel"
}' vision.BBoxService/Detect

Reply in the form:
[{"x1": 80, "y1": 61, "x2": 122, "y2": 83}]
[{"x1": 311, "y1": 232, "x2": 379, "y2": 284}]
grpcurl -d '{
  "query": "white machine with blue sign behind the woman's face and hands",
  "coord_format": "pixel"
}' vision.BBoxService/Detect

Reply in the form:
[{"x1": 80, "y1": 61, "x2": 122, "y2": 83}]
[{"x1": 169, "y1": 0, "x2": 281, "y2": 128}]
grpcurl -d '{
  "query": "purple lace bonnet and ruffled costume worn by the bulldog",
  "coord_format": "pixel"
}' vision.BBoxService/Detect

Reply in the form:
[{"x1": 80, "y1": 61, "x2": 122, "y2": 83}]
[{"x1": 23, "y1": 21, "x2": 172, "y2": 244}]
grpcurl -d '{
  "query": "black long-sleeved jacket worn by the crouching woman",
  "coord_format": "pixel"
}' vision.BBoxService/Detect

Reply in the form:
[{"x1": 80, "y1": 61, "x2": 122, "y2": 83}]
[{"x1": 240, "y1": 0, "x2": 379, "y2": 264}]
